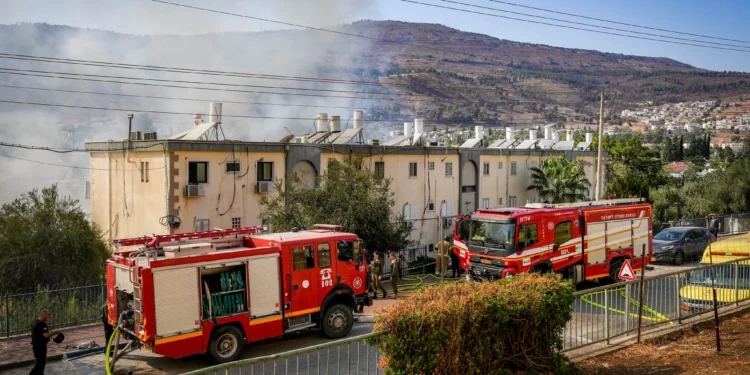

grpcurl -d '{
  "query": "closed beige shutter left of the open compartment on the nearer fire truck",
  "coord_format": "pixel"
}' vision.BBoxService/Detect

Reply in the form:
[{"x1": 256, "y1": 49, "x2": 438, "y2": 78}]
[{"x1": 152, "y1": 265, "x2": 201, "y2": 338}]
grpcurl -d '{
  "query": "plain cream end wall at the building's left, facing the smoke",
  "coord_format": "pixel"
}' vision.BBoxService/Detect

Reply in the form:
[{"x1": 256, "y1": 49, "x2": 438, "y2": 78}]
[{"x1": 90, "y1": 151, "x2": 169, "y2": 240}]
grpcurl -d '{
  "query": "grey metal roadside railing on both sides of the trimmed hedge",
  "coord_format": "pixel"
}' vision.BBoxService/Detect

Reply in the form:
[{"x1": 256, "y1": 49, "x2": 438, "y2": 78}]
[{"x1": 187, "y1": 258, "x2": 750, "y2": 375}]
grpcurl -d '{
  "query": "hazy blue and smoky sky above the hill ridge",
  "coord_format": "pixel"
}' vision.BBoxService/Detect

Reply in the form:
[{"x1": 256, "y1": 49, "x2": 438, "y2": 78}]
[{"x1": 0, "y1": 0, "x2": 750, "y2": 71}]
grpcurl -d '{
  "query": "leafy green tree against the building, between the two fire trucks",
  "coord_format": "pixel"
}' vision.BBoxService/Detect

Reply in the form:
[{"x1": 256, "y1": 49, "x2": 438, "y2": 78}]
[{"x1": 260, "y1": 159, "x2": 411, "y2": 251}]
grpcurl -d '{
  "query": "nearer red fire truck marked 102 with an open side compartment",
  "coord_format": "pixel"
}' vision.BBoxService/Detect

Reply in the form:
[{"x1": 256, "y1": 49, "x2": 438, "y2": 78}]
[{"x1": 107, "y1": 225, "x2": 372, "y2": 366}]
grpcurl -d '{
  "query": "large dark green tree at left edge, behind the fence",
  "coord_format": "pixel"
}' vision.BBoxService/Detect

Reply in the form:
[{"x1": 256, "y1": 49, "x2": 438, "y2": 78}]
[{"x1": 0, "y1": 185, "x2": 110, "y2": 293}]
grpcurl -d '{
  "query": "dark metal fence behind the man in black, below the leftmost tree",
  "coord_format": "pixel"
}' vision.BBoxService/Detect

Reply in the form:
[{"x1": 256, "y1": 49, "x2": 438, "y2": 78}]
[{"x1": 0, "y1": 284, "x2": 107, "y2": 337}]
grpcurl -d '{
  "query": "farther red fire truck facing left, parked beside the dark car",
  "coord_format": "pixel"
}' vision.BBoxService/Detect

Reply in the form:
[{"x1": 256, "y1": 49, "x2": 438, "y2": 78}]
[{"x1": 454, "y1": 199, "x2": 652, "y2": 284}]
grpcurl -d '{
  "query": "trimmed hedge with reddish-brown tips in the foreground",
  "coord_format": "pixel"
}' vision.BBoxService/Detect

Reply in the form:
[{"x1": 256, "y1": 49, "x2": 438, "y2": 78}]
[{"x1": 373, "y1": 274, "x2": 575, "y2": 375}]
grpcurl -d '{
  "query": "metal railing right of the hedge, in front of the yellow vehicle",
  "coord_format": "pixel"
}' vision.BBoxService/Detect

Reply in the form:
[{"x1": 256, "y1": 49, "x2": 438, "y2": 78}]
[{"x1": 563, "y1": 258, "x2": 750, "y2": 350}]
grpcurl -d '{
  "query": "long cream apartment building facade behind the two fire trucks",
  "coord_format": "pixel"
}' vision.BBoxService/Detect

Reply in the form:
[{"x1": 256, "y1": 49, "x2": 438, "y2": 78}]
[{"x1": 86, "y1": 132, "x2": 604, "y2": 250}]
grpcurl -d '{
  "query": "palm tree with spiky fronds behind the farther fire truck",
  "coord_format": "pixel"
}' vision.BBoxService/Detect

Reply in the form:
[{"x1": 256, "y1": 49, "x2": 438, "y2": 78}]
[{"x1": 526, "y1": 157, "x2": 591, "y2": 203}]
